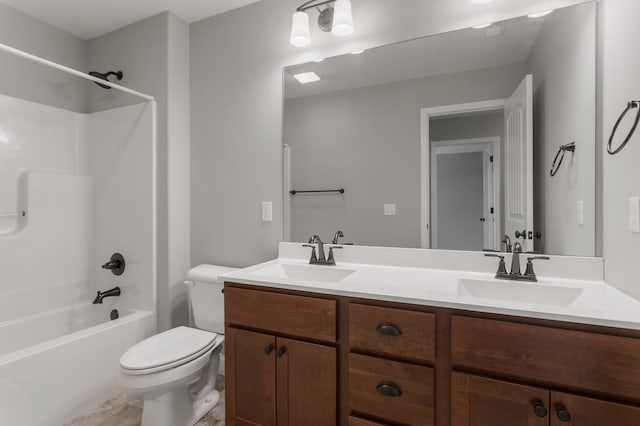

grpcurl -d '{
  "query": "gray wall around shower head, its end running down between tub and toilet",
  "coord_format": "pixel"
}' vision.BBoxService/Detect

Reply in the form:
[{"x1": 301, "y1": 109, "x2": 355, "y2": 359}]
[{"x1": 88, "y1": 13, "x2": 190, "y2": 330}]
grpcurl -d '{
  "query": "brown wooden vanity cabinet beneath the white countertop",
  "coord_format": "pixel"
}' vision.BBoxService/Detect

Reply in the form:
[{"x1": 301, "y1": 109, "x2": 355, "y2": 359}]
[{"x1": 225, "y1": 282, "x2": 640, "y2": 426}]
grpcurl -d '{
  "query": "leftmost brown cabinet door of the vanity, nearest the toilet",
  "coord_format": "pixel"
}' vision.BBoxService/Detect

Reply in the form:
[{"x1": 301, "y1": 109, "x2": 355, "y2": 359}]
[{"x1": 225, "y1": 327, "x2": 276, "y2": 426}]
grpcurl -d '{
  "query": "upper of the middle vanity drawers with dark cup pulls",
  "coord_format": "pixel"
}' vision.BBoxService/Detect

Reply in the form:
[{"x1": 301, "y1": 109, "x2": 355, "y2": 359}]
[{"x1": 349, "y1": 303, "x2": 436, "y2": 362}]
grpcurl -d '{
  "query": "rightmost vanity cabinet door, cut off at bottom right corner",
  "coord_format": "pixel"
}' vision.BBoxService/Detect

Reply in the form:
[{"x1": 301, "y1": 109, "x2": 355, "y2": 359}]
[{"x1": 550, "y1": 392, "x2": 640, "y2": 426}]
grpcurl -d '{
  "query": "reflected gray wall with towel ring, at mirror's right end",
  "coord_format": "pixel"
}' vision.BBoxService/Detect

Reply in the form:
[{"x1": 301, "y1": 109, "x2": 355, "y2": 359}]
[{"x1": 528, "y1": 4, "x2": 596, "y2": 256}]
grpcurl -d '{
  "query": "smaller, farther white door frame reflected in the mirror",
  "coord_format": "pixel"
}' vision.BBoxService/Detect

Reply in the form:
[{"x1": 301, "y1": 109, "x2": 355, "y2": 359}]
[{"x1": 429, "y1": 136, "x2": 502, "y2": 250}]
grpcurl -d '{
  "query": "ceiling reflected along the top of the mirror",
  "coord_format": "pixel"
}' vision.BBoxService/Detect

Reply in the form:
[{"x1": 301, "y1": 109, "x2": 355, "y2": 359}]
[{"x1": 284, "y1": 14, "x2": 553, "y2": 99}]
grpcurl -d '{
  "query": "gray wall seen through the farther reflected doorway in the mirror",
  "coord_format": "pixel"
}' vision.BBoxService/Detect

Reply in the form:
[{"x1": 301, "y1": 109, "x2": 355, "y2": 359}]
[{"x1": 432, "y1": 152, "x2": 484, "y2": 251}]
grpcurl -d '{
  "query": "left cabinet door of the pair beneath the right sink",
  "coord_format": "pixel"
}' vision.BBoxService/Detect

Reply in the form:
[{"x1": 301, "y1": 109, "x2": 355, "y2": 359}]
[{"x1": 451, "y1": 372, "x2": 549, "y2": 426}]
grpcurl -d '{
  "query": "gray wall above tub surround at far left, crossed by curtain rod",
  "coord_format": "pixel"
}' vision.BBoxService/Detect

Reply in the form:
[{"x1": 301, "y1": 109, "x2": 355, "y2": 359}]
[{"x1": 0, "y1": 4, "x2": 89, "y2": 112}]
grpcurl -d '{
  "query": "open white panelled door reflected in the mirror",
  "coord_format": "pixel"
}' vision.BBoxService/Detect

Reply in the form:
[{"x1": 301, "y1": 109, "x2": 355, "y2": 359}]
[{"x1": 504, "y1": 74, "x2": 533, "y2": 251}]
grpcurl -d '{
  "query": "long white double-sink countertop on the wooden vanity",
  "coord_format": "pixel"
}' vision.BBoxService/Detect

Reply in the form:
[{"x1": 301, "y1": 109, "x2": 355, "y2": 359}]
[{"x1": 221, "y1": 243, "x2": 640, "y2": 330}]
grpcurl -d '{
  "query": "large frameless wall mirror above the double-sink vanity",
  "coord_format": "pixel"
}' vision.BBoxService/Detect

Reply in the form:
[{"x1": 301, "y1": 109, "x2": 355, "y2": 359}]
[{"x1": 283, "y1": 2, "x2": 598, "y2": 256}]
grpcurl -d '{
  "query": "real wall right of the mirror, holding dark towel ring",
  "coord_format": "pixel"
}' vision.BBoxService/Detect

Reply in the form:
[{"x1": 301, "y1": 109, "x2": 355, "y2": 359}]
[{"x1": 601, "y1": 0, "x2": 640, "y2": 298}]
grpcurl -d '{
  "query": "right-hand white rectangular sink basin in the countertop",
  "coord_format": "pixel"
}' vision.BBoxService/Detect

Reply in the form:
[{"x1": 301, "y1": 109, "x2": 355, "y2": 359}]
[{"x1": 458, "y1": 279, "x2": 582, "y2": 306}]
